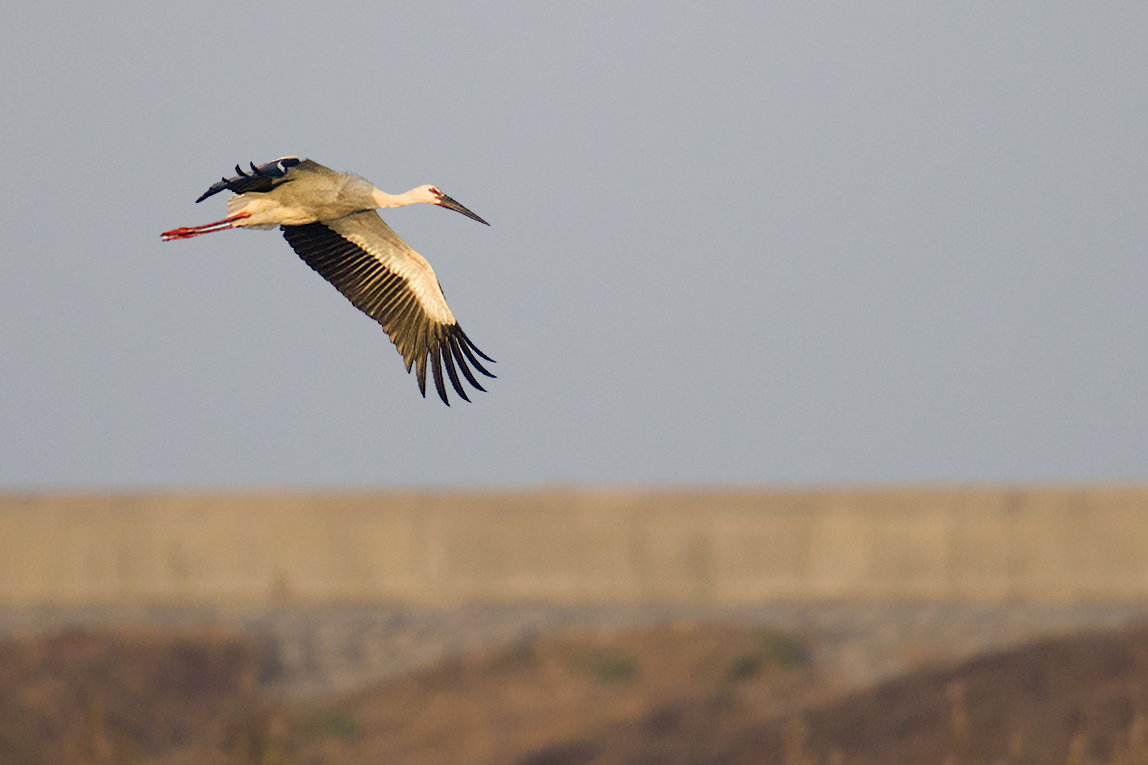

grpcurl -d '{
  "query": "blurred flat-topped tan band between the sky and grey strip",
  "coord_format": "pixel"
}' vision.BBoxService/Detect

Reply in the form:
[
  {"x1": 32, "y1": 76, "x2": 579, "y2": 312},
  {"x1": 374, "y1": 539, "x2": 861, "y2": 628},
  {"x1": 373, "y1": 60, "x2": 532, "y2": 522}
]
[{"x1": 0, "y1": 487, "x2": 1148, "y2": 605}]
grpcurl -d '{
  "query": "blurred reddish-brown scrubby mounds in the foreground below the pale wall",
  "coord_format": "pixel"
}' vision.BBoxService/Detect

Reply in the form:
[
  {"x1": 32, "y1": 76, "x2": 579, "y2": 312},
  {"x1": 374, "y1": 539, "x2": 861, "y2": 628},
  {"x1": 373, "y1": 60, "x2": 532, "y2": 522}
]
[{"x1": 0, "y1": 624, "x2": 1148, "y2": 765}]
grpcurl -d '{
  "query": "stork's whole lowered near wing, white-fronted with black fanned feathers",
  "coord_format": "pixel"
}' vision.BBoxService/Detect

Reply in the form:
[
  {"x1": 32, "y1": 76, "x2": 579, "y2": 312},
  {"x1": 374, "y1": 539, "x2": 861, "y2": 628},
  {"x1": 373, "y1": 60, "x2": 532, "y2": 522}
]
[{"x1": 280, "y1": 205, "x2": 494, "y2": 407}]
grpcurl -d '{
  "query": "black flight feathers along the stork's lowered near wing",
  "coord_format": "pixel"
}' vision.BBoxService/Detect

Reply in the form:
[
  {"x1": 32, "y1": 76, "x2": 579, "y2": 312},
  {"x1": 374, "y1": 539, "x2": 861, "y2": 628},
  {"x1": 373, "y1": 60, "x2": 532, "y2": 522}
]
[{"x1": 280, "y1": 217, "x2": 494, "y2": 405}]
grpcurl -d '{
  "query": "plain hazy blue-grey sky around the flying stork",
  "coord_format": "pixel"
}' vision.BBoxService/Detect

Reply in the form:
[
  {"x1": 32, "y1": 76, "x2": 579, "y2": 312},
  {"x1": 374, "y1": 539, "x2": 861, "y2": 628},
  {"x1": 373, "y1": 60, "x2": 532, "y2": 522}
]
[{"x1": 0, "y1": 0, "x2": 1148, "y2": 489}]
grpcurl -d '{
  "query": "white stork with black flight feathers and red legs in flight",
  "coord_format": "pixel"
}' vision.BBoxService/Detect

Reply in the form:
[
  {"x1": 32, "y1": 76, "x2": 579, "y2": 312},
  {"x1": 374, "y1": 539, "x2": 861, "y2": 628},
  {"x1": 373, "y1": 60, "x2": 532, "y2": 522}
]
[{"x1": 162, "y1": 156, "x2": 494, "y2": 407}]
